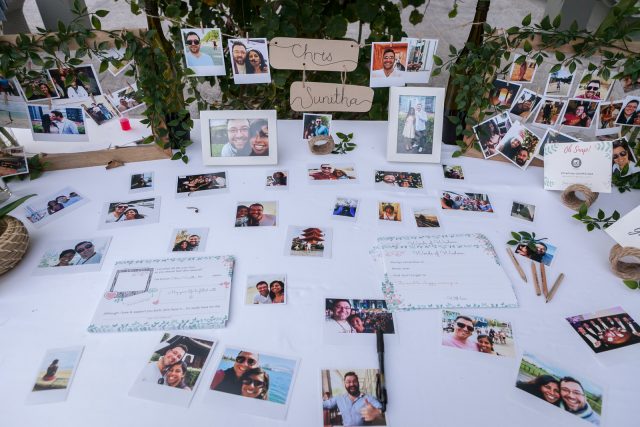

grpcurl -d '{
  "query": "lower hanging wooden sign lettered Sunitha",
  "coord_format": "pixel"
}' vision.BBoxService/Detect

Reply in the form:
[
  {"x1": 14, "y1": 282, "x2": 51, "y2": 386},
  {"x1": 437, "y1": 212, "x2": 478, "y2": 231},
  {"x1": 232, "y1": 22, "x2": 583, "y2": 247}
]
[{"x1": 289, "y1": 82, "x2": 373, "y2": 113}]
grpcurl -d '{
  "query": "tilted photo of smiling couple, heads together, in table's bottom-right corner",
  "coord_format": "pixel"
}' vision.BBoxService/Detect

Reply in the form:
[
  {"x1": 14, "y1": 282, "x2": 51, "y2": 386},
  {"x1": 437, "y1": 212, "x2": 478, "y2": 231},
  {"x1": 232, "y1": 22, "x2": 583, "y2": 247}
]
[{"x1": 516, "y1": 353, "x2": 604, "y2": 426}]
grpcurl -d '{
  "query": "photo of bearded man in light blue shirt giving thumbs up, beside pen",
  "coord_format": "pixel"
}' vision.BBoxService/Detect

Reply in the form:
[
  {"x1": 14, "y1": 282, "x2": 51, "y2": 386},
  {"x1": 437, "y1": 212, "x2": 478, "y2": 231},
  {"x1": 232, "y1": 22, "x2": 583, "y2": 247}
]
[{"x1": 321, "y1": 369, "x2": 387, "y2": 427}]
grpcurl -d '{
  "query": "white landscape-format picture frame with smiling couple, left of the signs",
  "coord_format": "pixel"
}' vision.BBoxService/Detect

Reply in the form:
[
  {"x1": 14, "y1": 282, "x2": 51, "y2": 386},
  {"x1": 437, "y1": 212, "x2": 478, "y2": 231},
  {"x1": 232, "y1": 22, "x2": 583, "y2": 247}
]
[{"x1": 200, "y1": 110, "x2": 278, "y2": 166}]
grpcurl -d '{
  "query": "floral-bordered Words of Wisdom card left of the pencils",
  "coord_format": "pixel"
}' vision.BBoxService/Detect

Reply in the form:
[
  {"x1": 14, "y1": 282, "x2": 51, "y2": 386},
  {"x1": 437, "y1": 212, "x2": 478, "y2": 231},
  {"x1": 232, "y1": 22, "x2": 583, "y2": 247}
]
[{"x1": 371, "y1": 234, "x2": 518, "y2": 310}]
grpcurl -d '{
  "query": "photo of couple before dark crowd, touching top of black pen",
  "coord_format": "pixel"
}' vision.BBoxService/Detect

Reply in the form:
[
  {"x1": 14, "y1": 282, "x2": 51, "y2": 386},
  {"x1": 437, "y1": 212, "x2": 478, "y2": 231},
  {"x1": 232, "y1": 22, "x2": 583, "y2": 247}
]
[{"x1": 324, "y1": 298, "x2": 395, "y2": 334}]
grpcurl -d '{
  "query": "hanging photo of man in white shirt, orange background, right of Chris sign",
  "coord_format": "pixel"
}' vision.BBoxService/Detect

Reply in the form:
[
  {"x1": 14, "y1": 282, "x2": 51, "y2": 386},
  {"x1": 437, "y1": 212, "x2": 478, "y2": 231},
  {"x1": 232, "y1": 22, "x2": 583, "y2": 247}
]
[{"x1": 369, "y1": 42, "x2": 409, "y2": 87}]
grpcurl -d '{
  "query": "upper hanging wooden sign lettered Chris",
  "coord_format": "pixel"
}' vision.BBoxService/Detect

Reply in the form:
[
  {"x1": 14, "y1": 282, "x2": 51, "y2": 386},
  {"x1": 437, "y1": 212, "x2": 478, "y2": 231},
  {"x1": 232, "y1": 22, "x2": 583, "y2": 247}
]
[{"x1": 269, "y1": 37, "x2": 360, "y2": 71}]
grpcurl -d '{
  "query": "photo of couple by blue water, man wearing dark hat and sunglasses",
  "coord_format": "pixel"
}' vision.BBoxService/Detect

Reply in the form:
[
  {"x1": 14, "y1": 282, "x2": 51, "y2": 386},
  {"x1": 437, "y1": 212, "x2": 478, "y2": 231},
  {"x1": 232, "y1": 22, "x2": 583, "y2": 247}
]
[{"x1": 206, "y1": 347, "x2": 300, "y2": 420}]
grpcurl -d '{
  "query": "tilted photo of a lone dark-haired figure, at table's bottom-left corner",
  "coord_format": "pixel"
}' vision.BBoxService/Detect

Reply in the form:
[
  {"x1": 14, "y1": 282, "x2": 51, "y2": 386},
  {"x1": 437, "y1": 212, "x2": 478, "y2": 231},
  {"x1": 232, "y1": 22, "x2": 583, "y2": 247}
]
[{"x1": 26, "y1": 346, "x2": 84, "y2": 404}]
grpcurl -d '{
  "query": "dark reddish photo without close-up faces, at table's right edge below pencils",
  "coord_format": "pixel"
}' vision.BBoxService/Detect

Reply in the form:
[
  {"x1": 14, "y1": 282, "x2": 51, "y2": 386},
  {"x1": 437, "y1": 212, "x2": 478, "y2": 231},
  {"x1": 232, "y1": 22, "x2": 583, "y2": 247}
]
[{"x1": 567, "y1": 307, "x2": 640, "y2": 353}]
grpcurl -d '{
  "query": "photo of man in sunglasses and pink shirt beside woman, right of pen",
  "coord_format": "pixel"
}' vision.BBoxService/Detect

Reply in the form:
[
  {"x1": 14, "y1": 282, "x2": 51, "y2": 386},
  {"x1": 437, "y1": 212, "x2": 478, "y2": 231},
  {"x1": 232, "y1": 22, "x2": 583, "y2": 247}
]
[{"x1": 442, "y1": 310, "x2": 515, "y2": 357}]
